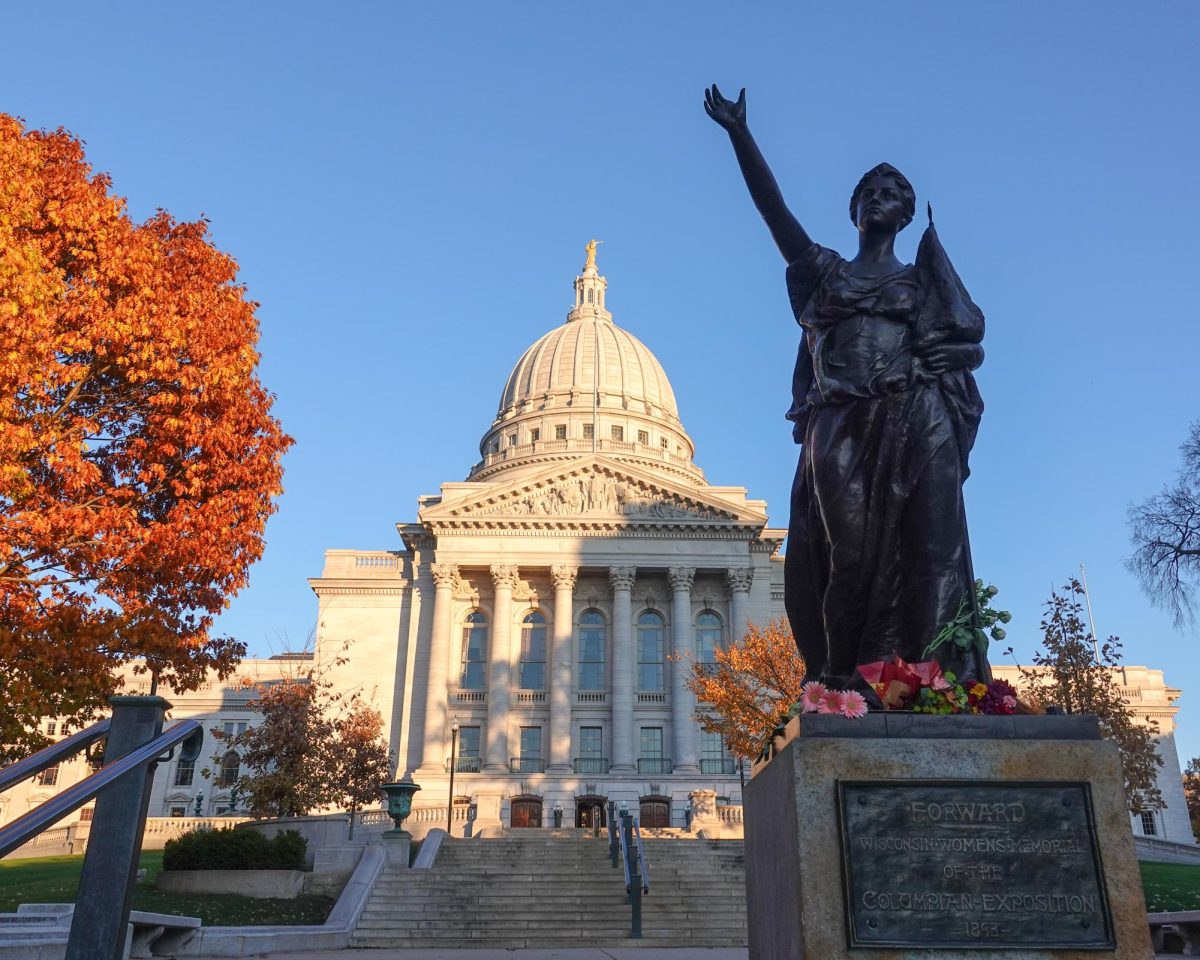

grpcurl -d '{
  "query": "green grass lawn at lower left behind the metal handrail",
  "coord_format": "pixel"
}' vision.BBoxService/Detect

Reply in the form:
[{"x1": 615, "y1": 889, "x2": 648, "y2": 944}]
[{"x1": 0, "y1": 850, "x2": 334, "y2": 926}]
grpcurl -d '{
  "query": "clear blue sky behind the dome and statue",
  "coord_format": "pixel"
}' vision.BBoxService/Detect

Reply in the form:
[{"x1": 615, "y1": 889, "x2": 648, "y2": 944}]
[{"x1": 0, "y1": 0, "x2": 1200, "y2": 758}]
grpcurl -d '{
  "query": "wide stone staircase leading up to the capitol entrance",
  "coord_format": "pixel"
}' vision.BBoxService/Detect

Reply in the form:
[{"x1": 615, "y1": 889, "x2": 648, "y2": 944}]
[{"x1": 350, "y1": 829, "x2": 746, "y2": 949}]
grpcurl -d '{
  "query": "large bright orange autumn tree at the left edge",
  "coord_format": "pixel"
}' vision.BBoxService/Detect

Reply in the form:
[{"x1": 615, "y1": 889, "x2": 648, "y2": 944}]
[{"x1": 0, "y1": 114, "x2": 292, "y2": 756}]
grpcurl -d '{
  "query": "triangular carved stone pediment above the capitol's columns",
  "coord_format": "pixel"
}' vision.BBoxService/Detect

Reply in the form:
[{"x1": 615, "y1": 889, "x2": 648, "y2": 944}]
[{"x1": 421, "y1": 457, "x2": 767, "y2": 526}]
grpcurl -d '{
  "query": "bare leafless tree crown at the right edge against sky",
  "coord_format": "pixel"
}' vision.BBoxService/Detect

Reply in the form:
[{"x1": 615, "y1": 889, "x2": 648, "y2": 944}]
[{"x1": 1126, "y1": 420, "x2": 1200, "y2": 628}]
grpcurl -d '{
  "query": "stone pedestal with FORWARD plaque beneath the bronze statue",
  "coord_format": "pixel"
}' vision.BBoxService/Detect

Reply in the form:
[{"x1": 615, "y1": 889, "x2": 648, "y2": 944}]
[{"x1": 745, "y1": 713, "x2": 1153, "y2": 960}]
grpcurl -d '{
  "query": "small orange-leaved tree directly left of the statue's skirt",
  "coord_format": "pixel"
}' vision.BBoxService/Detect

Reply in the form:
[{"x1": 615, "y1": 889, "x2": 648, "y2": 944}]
[{"x1": 688, "y1": 619, "x2": 804, "y2": 758}]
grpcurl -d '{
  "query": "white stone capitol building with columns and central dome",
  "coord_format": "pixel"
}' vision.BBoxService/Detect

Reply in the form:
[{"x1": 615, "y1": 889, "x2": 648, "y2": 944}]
[{"x1": 0, "y1": 242, "x2": 1194, "y2": 844}]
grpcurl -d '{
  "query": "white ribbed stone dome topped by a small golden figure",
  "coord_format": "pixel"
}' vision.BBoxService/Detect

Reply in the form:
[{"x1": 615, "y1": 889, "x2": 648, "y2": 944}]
[{"x1": 469, "y1": 245, "x2": 703, "y2": 482}]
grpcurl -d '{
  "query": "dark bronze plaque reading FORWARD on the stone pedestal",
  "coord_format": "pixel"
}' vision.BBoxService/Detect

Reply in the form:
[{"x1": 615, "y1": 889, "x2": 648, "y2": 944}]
[{"x1": 838, "y1": 780, "x2": 1116, "y2": 950}]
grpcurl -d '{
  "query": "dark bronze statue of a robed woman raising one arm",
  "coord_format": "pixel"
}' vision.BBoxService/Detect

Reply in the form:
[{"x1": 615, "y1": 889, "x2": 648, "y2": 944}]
[{"x1": 704, "y1": 84, "x2": 989, "y2": 689}]
